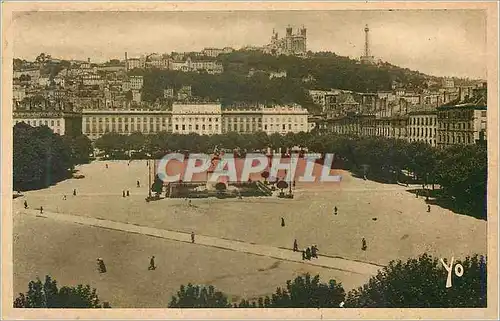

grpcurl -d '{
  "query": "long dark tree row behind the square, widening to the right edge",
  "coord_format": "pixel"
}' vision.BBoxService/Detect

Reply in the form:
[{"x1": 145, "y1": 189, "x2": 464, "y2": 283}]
[{"x1": 95, "y1": 132, "x2": 488, "y2": 219}]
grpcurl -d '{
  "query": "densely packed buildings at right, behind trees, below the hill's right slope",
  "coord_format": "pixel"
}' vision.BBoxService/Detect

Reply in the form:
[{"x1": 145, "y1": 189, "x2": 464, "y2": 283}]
[{"x1": 316, "y1": 83, "x2": 487, "y2": 147}]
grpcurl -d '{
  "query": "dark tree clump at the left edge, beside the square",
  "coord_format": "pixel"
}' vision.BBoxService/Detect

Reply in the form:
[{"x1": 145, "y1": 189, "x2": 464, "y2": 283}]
[{"x1": 13, "y1": 123, "x2": 92, "y2": 190}]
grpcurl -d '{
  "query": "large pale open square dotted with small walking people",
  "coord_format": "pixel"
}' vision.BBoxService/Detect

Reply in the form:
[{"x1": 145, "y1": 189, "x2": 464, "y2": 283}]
[{"x1": 13, "y1": 161, "x2": 487, "y2": 307}]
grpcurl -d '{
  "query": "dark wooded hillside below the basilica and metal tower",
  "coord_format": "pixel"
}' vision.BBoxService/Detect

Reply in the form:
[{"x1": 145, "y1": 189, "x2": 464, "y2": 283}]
[{"x1": 131, "y1": 51, "x2": 446, "y2": 109}]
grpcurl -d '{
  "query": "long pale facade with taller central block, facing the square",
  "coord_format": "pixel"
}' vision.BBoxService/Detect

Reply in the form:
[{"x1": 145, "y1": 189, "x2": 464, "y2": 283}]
[{"x1": 82, "y1": 103, "x2": 311, "y2": 140}]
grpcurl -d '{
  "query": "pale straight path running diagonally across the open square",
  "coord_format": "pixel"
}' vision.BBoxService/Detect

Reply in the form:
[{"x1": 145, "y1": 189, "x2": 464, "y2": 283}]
[{"x1": 18, "y1": 210, "x2": 382, "y2": 275}]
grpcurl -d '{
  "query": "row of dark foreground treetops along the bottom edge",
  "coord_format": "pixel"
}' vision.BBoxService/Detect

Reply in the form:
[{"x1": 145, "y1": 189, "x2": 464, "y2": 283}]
[{"x1": 14, "y1": 254, "x2": 487, "y2": 308}]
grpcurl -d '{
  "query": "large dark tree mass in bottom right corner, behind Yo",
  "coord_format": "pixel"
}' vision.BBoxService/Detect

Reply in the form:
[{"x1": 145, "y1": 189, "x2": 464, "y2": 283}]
[{"x1": 346, "y1": 254, "x2": 487, "y2": 308}]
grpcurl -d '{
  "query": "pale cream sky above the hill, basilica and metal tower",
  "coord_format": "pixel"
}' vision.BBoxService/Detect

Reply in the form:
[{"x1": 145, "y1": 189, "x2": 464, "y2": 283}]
[{"x1": 13, "y1": 10, "x2": 487, "y2": 79}]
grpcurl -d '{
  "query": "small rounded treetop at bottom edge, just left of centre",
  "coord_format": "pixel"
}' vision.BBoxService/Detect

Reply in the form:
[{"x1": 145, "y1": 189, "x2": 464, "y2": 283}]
[{"x1": 168, "y1": 283, "x2": 231, "y2": 308}]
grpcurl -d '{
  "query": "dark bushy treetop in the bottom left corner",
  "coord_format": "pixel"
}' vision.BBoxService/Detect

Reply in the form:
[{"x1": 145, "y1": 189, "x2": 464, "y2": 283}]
[{"x1": 14, "y1": 275, "x2": 105, "y2": 308}]
